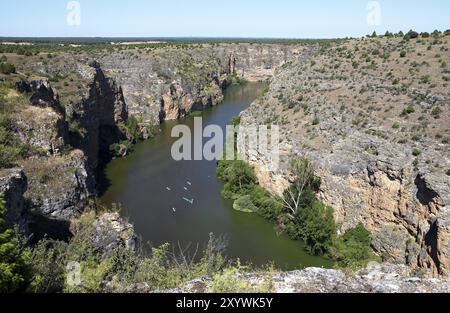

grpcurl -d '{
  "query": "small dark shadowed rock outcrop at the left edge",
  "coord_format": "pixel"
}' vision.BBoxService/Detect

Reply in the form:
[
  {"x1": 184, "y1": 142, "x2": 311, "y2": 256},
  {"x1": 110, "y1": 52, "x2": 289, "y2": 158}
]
[{"x1": 0, "y1": 169, "x2": 28, "y2": 232}]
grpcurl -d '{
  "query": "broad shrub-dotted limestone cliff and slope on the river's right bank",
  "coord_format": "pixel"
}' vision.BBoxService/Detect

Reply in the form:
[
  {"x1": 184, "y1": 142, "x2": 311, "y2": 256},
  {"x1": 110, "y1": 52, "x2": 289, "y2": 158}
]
[{"x1": 242, "y1": 39, "x2": 450, "y2": 275}]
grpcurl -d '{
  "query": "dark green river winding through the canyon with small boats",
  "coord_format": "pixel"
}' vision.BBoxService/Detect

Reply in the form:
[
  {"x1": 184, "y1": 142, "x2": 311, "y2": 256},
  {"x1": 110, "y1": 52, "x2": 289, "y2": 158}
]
[{"x1": 101, "y1": 84, "x2": 331, "y2": 269}]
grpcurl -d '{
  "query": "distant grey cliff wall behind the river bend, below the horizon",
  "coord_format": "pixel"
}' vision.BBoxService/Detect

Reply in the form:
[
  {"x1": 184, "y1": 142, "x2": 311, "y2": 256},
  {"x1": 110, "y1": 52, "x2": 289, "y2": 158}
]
[{"x1": 100, "y1": 44, "x2": 296, "y2": 124}]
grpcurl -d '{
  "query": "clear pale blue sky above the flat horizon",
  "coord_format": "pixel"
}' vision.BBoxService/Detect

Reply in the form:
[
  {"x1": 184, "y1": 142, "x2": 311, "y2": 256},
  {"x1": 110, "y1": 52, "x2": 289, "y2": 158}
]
[{"x1": 0, "y1": 0, "x2": 450, "y2": 38}]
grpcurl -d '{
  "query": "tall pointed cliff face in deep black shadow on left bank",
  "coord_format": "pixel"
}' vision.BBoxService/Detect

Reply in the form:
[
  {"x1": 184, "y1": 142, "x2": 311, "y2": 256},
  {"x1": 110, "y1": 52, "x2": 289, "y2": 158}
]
[{"x1": 69, "y1": 63, "x2": 128, "y2": 170}]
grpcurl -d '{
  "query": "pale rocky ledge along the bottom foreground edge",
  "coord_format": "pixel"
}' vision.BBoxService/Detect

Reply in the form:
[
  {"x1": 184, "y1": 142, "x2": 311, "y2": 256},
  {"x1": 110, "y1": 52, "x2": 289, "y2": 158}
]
[{"x1": 170, "y1": 264, "x2": 450, "y2": 293}]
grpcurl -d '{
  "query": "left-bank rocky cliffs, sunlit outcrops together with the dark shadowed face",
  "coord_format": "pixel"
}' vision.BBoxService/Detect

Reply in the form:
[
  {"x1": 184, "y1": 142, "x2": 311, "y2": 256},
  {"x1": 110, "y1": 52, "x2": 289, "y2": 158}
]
[{"x1": 6, "y1": 62, "x2": 128, "y2": 224}]
